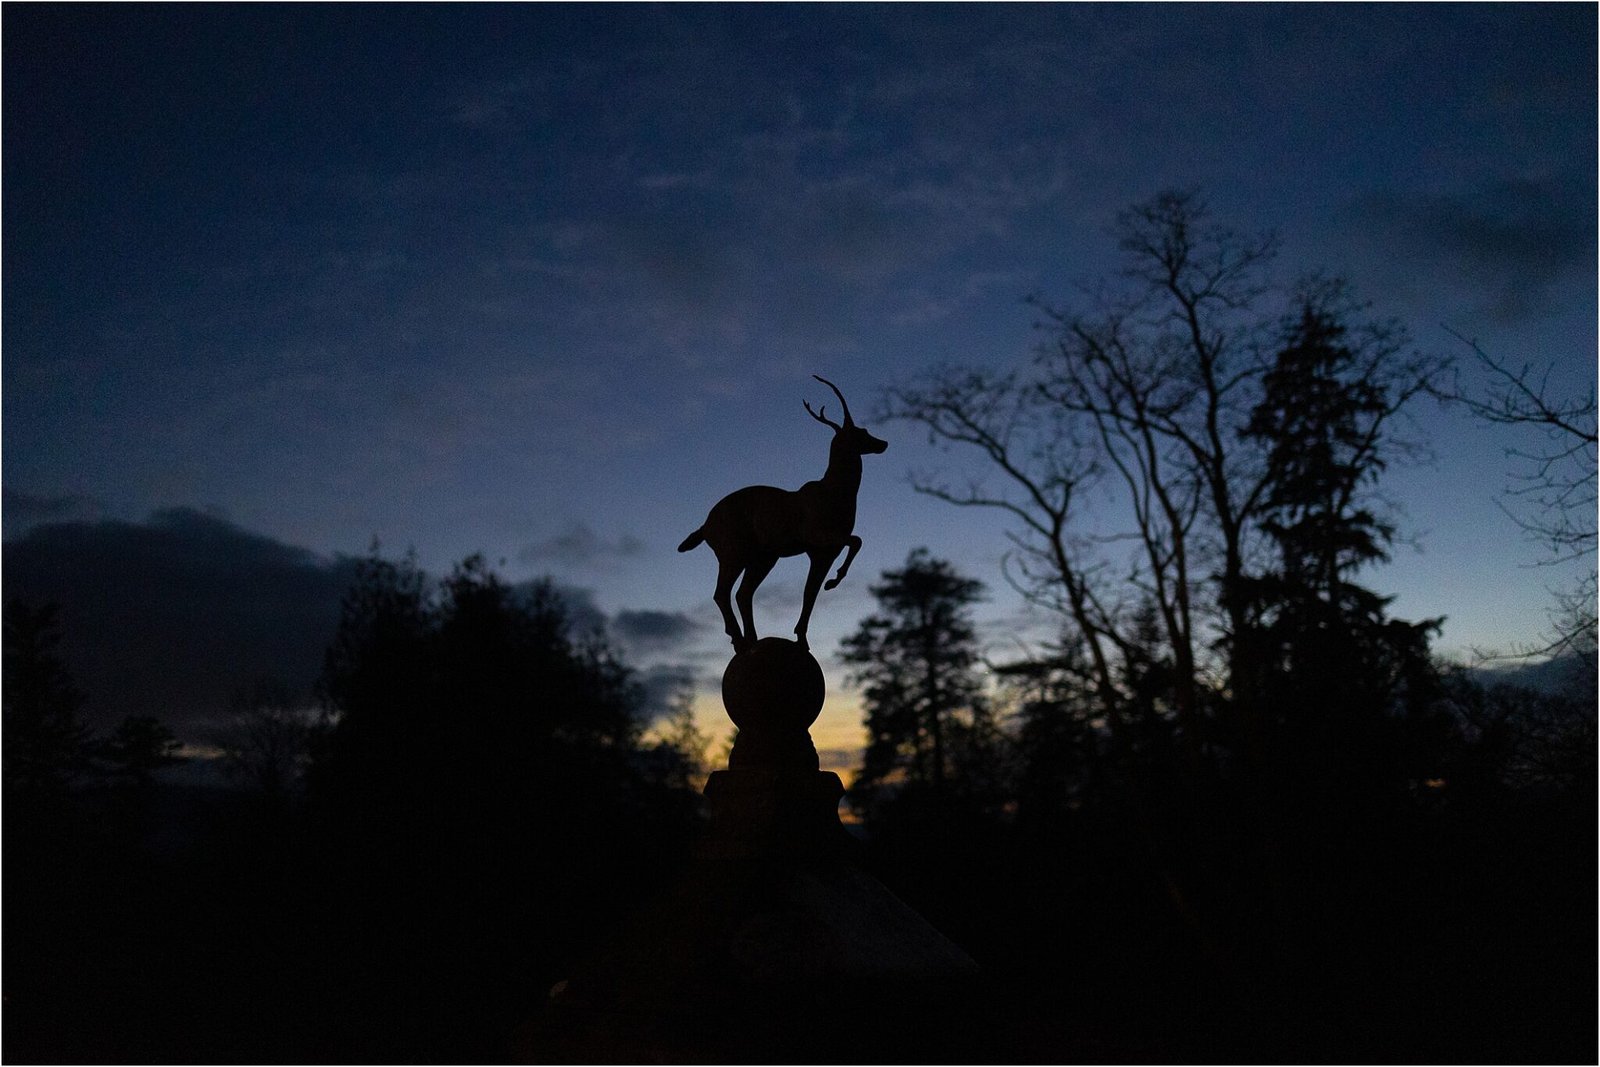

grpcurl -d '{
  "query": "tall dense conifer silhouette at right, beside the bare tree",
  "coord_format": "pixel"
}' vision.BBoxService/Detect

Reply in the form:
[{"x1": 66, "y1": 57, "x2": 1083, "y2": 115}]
[{"x1": 1235, "y1": 288, "x2": 1442, "y2": 783}]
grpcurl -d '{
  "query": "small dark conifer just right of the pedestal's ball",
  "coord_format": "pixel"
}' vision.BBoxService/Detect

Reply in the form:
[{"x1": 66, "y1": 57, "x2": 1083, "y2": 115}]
[{"x1": 843, "y1": 549, "x2": 995, "y2": 813}]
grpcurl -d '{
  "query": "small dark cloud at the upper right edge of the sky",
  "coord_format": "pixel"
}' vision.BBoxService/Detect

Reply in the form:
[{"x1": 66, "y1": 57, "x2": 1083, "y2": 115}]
[{"x1": 1355, "y1": 179, "x2": 1595, "y2": 322}]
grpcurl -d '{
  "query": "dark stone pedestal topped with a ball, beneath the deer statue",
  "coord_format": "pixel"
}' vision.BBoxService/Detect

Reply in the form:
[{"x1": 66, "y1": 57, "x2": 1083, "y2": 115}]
[{"x1": 525, "y1": 638, "x2": 978, "y2": 1062}]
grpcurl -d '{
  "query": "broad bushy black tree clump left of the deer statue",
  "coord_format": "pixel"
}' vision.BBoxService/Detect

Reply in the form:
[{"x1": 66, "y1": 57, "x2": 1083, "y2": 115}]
[{"x1": 312, "y1": 553, "x2": 656, "y2": 854}]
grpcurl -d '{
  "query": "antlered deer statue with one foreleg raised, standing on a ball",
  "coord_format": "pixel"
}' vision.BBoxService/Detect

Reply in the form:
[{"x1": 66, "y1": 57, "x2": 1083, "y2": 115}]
[{"x1": 678, "y1": 374, "x2": 888, "y2": 653}]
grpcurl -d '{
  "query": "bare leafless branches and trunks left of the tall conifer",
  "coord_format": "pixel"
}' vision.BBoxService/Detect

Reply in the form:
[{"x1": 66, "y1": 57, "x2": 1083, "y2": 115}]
[{"x1": 890, "y1": 192, "x2": 1275, "y2": 737}]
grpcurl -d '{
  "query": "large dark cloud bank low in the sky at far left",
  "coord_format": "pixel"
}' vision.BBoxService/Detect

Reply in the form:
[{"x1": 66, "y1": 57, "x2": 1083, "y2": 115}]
[{"x1": 5, "y1": 509, "x2": 355, "y2": 736}]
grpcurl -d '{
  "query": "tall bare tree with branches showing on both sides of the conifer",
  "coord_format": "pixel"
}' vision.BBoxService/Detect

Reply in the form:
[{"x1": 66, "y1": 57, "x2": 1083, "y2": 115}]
[{"x1": 886, "y1": 192, "x2": 1443, "y2": 744}]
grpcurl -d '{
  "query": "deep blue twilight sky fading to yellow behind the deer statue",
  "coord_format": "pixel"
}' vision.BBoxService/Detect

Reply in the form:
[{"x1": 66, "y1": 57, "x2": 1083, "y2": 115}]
[{"x1": 3, "y1": 5, "x2": 1597, "y2": 764}]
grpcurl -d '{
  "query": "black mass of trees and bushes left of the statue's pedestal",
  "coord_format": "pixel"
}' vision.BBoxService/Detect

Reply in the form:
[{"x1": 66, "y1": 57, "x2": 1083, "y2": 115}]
[{"x1": 5, "y1": 553, "x2": 698, "y2": 1062}]
